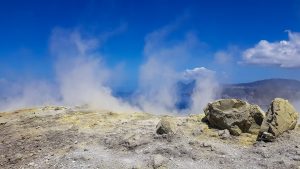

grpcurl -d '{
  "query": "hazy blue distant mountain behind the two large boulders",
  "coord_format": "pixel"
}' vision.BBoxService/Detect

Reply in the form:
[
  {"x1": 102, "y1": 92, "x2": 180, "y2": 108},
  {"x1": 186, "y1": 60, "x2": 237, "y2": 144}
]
[{"x1": 220, "y1": 79, "x2": 300, "y2": 109}]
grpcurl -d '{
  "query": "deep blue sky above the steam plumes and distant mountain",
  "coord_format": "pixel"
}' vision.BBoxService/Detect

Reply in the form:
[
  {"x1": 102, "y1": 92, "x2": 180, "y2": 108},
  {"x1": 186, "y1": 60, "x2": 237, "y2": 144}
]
[{"x1": 0, "y1": 0, "x2": 300, "y2": 91}]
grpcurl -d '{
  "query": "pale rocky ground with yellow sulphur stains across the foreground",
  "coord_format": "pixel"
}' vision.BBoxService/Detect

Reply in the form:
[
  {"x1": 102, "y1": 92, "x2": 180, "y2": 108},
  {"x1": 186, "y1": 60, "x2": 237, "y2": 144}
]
[{"x1": 0, "y1": 107, "x2": 300, "y2": 169}]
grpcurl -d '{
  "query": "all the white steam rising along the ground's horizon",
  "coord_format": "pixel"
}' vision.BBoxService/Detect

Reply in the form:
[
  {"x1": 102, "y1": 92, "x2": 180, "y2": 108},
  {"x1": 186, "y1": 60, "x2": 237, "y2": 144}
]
[{"x1": 0, "y1": 24, "x2": 218, "y2": 114}]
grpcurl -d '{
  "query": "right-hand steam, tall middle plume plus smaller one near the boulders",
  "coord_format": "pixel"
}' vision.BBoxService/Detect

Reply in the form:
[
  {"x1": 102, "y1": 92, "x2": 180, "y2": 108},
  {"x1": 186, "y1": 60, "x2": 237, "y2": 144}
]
[{"x1": 136, "y1": 22, "x2": 216, "y2": 114}]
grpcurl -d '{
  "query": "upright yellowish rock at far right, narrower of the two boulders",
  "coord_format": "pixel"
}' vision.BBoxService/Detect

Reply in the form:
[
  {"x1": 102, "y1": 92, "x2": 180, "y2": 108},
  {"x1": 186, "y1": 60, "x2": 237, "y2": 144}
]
[{"x1": 257, "y1": 98, "x2": 298, "y2": 141}]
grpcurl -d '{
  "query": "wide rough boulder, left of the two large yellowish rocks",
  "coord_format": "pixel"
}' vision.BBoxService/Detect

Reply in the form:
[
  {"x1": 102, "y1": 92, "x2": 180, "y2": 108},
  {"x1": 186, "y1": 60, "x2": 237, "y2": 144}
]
[{"x1": 204, "y1": 99, "x2": 264, "y2": 135}]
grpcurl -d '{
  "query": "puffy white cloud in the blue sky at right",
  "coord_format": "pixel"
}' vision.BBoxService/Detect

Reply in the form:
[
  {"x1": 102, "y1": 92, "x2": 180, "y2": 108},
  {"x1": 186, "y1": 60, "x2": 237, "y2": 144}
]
[{"x1": 243, "y1": 31, "x2": 300, "y2": 68}]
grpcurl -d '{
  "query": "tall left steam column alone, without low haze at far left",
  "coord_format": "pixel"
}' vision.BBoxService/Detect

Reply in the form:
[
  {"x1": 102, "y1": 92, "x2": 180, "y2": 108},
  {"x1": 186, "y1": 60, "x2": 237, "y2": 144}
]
[{"x1": 50, "y1": 30, "x2": 137, "y2": 111}]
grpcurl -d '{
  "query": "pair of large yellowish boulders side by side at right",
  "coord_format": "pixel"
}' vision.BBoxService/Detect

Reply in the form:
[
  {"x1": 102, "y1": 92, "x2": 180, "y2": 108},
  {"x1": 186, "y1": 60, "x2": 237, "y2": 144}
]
[{"x1": 203, "y1": 98, "x2": 298, "y2": 141}]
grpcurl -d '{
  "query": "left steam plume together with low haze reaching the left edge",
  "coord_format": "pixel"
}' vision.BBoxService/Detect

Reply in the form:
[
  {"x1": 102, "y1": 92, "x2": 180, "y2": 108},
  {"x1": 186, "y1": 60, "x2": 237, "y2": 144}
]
[{"x1": 0, "y1": 29, "x2": 138, "y2": 111}]
